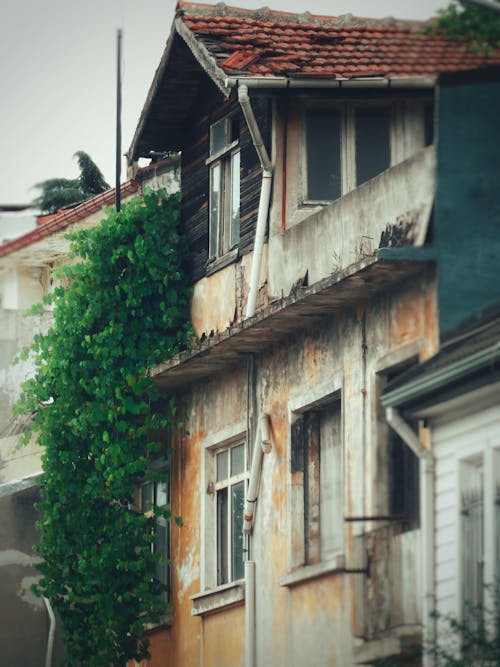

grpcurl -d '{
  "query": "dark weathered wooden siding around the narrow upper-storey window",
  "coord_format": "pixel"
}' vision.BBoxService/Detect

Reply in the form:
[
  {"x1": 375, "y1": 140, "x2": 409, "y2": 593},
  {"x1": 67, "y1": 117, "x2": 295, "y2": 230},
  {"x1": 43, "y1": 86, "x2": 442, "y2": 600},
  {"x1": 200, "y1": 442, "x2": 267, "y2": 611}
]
[{"x1": 181, "y1": 84, "x2": 270, "y2": 282}]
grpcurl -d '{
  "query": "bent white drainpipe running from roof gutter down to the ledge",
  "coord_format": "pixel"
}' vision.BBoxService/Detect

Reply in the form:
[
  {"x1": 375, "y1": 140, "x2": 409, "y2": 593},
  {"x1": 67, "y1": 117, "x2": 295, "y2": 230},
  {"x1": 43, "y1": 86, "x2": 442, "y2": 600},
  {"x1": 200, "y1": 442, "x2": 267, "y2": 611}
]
[{"x1": 238, "y1": 84, "x2": 273, "y2": 318}]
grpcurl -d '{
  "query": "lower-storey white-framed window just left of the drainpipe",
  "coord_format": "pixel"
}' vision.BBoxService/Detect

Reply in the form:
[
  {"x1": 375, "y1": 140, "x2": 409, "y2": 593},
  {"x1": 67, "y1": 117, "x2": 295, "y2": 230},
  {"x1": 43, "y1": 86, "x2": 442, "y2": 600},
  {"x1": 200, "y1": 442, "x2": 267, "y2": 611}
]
[{"x1": 214, "y1": 443, "x2": 246, "y2": 586}]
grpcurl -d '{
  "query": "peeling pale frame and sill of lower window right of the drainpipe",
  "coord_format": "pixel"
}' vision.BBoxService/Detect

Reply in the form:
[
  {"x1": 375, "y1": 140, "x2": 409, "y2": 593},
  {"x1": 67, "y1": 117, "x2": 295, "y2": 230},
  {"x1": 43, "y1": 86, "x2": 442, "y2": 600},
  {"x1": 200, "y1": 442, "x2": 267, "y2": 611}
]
[{"x1": 280, "y1": 375, "x2": 346, "y2": 586}]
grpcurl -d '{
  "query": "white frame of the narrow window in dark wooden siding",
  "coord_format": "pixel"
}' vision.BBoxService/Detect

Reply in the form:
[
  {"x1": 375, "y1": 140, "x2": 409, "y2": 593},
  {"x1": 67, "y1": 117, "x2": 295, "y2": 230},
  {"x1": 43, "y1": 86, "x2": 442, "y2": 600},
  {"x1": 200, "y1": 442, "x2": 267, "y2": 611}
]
[{"x1": 205, "y1": 115, "x2": 241, "y2": 265}]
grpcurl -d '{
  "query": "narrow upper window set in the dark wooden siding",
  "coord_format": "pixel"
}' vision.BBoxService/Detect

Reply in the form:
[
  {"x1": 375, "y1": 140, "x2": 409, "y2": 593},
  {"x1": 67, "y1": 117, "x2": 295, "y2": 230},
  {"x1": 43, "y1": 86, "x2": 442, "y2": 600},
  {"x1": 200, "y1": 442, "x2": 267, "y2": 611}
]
[{"x1": 207, "y1": 117, "x2": 240, "y2": 259}]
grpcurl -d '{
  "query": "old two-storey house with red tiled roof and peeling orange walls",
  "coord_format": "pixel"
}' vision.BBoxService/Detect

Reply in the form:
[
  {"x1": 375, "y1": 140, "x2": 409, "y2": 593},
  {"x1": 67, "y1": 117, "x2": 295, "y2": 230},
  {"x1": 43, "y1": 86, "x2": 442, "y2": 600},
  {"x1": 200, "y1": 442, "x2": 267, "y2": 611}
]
[{"x1": 129, "y1": 2, "x2": 500, "y2": 667}]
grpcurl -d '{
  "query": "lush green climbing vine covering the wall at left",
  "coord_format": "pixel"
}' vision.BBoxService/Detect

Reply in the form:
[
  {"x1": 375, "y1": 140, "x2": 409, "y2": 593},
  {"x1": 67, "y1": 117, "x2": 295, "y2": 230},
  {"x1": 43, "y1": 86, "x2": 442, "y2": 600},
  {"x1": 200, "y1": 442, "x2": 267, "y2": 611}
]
[{"x1": 18, "y1": 191, "x2": 190, "y2": 667}]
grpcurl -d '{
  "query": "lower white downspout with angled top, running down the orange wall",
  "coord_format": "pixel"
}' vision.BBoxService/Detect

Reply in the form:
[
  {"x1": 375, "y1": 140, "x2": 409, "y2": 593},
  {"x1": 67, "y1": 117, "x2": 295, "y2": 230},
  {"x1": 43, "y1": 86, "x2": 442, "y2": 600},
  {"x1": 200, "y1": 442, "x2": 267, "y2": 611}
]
[{"x1": 243, "y1": 415, "x2": 271, "y2": 667}]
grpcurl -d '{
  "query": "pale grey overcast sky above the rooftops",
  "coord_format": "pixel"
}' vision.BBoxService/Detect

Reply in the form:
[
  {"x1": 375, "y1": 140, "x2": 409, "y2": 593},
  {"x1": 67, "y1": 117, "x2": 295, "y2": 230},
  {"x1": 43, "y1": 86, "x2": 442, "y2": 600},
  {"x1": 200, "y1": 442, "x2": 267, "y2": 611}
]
[{"x1": 0, "y1": 0, "x2": 448, "y2": 204}]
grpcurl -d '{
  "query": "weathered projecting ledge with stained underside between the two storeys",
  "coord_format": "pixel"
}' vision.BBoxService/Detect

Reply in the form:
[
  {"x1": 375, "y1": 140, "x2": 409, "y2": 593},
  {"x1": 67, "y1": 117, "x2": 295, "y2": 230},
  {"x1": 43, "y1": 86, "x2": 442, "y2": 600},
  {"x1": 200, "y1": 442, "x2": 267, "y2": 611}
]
[{"x1": 150, "y1": 255, "x2": 433, "y2": 391}]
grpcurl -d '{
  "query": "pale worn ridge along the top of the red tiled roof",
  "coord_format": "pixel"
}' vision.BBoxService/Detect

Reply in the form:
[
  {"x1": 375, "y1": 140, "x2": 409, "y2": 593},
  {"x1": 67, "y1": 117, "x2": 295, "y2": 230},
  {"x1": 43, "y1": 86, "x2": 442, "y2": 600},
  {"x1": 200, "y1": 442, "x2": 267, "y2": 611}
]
[{"x1": 177, "y1": 0, "x2": 426, "y2": 28}]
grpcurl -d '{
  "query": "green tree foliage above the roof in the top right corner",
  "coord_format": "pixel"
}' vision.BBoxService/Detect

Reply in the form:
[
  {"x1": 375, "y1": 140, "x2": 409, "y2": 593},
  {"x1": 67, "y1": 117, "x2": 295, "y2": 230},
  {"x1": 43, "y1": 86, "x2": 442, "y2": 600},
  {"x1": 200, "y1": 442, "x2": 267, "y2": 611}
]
[{"x1": 429, "y1": 0, "x2": 500, "y2": 53}]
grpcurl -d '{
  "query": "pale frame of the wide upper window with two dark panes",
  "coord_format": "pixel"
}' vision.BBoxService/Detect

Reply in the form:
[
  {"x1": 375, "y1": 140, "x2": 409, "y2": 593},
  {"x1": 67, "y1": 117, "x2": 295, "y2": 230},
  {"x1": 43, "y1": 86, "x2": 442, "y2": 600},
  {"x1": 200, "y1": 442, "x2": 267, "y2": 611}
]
[{"x1": 300, "y1": 98, "x2": 429, "y2": 206}]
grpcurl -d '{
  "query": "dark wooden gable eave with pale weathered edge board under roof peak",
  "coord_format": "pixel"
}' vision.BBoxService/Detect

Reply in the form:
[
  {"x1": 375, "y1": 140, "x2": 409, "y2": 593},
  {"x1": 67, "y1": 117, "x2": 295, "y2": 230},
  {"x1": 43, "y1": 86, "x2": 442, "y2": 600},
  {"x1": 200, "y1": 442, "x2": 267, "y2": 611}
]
[{"x1": 128, "y1": 19, "x2": 231, "y2": 162}]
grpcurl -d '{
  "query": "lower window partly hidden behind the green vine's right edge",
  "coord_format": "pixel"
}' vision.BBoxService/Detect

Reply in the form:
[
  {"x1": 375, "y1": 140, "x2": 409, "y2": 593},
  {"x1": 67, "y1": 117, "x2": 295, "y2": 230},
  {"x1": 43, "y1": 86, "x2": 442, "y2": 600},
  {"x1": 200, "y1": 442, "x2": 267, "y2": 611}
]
[{"x1": 139, "y1": 458, "x2": 171, "y2": 602}]
